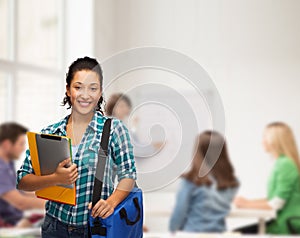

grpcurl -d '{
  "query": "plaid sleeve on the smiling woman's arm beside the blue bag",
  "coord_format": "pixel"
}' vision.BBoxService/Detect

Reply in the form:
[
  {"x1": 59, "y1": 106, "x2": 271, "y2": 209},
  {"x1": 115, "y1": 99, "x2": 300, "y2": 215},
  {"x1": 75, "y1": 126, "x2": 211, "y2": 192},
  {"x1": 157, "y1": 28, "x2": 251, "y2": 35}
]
[{"x1": 111, "y1": 119, "x2": 137, "y2": 181}]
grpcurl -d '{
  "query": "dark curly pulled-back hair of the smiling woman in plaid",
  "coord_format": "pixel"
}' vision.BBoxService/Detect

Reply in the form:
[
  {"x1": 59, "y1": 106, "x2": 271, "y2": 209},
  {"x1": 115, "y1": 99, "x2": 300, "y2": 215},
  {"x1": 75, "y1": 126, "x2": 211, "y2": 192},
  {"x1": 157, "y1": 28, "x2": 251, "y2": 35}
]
[{"x1": 62, "y1": 56, "x2": 104, "y2": 114}]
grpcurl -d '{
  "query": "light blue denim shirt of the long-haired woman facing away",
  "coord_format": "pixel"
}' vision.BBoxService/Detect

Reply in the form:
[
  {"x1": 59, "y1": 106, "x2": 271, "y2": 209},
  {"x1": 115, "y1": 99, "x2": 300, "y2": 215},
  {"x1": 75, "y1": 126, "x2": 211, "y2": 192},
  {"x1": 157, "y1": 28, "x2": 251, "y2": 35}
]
[{"x1": 169, "y1": 178, "x2": 237, "y2": 232}]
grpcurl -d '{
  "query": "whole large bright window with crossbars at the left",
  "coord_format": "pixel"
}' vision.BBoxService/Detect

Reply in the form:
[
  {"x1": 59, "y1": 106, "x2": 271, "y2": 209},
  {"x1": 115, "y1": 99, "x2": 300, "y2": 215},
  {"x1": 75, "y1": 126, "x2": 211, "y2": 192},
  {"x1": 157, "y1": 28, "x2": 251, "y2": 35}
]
[{"x1": 0, "y1": 0, "x2": 65, "y2": 130}]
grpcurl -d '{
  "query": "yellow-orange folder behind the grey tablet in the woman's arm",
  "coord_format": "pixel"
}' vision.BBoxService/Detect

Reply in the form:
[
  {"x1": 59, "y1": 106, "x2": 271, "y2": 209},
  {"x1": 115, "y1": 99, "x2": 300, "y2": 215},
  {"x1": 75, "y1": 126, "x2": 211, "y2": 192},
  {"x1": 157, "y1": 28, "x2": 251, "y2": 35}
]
[{"x1": 27, "y1": 132, "x2": 76, "y2": 205}]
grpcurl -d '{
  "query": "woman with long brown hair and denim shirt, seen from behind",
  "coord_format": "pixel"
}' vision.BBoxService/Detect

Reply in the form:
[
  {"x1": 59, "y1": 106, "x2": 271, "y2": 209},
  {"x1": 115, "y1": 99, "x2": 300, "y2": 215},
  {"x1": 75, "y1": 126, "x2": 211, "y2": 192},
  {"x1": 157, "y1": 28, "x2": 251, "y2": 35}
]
[{"x1": 169, "y1": 131, "x2": 238, "y2": 232}]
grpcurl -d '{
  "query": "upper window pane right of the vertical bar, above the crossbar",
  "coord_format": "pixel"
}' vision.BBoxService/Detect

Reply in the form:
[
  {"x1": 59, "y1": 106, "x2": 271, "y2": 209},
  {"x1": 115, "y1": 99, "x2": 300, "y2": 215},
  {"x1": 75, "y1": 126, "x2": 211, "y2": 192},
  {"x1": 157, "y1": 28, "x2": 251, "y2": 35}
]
[{"x1": 17, "y1": 0, "x2": 61, "y2": 68}]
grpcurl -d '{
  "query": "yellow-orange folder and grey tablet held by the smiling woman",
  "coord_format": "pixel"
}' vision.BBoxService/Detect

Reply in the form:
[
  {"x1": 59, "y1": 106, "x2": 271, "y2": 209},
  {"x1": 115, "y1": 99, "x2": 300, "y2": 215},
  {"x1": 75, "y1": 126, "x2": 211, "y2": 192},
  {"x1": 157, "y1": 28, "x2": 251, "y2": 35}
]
[{"x1": 27, "y1": 132, "x2": 76, "y2": 205}]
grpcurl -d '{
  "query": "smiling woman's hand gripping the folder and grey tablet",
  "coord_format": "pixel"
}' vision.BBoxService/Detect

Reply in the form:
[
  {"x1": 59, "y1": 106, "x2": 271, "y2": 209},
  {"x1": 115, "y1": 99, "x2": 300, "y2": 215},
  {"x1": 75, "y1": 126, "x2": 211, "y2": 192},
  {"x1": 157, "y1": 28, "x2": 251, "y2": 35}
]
[{"x1": 54, "y1": 159, "x2": 78, "y2": 185}]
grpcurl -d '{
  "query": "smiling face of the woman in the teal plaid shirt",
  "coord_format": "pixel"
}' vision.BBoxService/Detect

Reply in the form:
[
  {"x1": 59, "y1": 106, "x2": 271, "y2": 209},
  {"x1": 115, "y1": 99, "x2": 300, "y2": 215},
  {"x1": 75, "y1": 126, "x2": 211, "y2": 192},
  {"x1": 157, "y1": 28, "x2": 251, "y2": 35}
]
[{"x1": 67, "y1": 70, "x2": 102, "y2": 115}]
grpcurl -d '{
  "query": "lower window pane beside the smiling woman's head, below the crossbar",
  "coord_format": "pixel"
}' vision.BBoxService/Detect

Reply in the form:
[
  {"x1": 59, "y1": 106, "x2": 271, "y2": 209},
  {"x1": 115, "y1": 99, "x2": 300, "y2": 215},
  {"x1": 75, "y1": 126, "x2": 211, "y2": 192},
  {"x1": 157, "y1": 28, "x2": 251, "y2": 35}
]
[{"x1": 15, "y1": 71, "x2": 63, "y2": 131}]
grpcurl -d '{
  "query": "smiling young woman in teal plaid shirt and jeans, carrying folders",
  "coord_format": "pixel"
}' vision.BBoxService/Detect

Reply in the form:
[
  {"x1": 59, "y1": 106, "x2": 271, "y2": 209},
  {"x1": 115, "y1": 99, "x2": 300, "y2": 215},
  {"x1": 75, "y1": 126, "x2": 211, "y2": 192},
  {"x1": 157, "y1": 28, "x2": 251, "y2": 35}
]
[{"x1": 17, "y1": 57, "x2": 136, "y2": 238}]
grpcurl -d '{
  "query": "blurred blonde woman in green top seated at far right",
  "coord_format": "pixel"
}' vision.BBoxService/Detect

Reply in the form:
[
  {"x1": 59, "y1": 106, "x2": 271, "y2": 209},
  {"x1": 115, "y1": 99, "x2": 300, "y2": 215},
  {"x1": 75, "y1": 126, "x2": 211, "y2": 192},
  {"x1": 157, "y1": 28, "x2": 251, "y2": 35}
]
[{"x1": 235, "y1": 122, "x2": 300, "y2": 234}]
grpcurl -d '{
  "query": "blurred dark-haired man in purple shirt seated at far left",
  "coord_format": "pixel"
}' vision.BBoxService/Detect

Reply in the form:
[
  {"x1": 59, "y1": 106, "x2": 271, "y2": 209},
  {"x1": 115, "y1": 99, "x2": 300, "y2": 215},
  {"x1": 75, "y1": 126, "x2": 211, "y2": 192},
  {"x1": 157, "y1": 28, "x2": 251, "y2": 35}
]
[{"x1": 0, "y1": 123, "x2": 45, "y2": 226}]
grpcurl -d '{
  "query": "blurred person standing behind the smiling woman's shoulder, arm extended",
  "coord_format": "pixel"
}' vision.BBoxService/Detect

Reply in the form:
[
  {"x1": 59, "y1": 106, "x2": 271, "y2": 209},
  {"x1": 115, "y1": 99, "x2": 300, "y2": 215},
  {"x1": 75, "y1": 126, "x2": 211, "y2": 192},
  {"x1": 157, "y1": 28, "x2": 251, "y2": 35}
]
[{"x1": 105, "y1": 93, "x2": 164, "y2": 158}]
